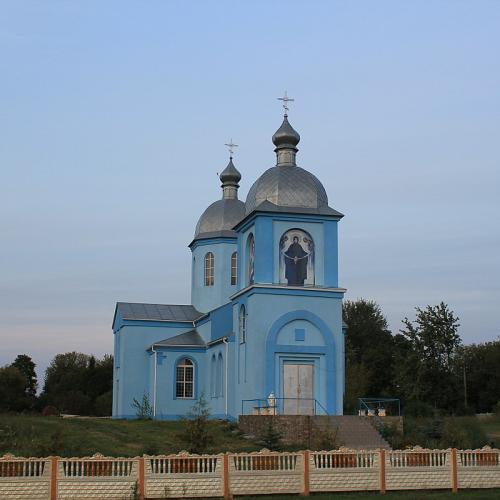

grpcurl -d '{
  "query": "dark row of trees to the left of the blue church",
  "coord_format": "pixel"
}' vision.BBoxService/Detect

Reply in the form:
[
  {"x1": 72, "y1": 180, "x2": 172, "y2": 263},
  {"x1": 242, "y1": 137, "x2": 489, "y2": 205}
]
[{"x1": 0, "y1": 352, "x2": 113, "y2": 416}]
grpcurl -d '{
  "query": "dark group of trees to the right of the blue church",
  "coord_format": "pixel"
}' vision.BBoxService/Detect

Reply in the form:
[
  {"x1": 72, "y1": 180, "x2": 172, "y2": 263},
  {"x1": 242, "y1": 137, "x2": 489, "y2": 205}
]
[{"x1": 343, "y1": 299, "x2": 500, "y2": 416}]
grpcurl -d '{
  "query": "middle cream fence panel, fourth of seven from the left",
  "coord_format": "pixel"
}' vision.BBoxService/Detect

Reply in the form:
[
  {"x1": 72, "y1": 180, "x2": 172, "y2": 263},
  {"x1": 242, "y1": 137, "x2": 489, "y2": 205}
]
[{"x1": 229, "y1": 450, "x2": 304, "y2": 495}]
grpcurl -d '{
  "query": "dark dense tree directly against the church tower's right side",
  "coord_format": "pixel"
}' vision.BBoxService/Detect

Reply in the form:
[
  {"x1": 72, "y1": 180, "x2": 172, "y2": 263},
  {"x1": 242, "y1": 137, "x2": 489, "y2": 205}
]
[{"x1": 343, "y1": 299, "x2": 393, "y2": 412}]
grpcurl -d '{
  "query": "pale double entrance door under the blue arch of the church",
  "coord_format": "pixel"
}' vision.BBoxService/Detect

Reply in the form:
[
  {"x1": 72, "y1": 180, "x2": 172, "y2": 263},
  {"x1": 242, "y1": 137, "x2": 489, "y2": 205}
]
[{"x1": 283, "y1": 363, "x2": 314, "y2": 415}]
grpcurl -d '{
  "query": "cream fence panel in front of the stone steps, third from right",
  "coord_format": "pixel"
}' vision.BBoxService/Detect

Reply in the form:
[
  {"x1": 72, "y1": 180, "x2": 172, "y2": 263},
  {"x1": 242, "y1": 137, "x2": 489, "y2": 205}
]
[{"x1": 309, "y1": 450, "x2": 379, "y2": 492}]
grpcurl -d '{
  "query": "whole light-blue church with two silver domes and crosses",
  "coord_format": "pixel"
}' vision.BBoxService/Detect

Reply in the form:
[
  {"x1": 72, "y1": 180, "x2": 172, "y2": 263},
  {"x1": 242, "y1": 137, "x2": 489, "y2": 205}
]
[{"x1": 113, "y1": 102, "x2": 346, "y2": 419}]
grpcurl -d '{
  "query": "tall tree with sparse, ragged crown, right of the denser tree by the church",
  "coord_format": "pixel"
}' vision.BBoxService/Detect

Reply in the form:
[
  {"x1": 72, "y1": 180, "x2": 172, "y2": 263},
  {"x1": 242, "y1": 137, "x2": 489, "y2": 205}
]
[{"x1": 395, "y1": 302, "x2": 461, "y2": 412}]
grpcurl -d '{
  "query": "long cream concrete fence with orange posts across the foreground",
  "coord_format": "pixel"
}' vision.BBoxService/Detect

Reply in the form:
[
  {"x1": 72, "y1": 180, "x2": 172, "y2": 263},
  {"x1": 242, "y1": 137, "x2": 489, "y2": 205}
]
[{"x1": 0, "y1": 448, "x2": 500, "y2": 500}]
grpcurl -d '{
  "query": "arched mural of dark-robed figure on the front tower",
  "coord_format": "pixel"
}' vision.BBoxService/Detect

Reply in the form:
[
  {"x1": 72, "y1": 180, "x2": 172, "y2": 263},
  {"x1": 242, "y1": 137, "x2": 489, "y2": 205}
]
[{"x1": 280, "y1": 229, "x2": 314, "y2": 286}]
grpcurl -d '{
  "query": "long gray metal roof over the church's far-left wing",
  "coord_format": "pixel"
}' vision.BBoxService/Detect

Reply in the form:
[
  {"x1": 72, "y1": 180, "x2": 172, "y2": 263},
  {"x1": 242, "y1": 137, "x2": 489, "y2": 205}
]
[{"x1": 116, "y1": 302, "x2": 204, "y2": 322}]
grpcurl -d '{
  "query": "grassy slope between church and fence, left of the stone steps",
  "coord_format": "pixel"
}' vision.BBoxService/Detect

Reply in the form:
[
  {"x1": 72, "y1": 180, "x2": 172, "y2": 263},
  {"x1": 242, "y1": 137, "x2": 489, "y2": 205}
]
[{"x1": 0, "y1": 415, "x2": 261, "y2": 457}]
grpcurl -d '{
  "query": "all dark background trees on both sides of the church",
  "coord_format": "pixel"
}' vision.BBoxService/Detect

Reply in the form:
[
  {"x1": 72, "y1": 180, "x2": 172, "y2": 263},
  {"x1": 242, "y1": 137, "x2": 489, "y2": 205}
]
[{"x1": 0, "y1": 299, "x2": 500, "y2": 416}]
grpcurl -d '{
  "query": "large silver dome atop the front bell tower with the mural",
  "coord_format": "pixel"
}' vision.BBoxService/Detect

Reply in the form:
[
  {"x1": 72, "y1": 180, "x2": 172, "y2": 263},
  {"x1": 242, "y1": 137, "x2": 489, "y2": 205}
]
[{"x1": 245, "y1": 166, "x2": 328, "y2": 214}]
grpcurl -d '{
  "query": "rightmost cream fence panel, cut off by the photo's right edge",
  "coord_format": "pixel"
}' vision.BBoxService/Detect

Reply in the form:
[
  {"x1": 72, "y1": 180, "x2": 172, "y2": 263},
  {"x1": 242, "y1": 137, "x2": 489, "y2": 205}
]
[{"x1": 457, "y1": 447, "x2": 500, "y2": 488}]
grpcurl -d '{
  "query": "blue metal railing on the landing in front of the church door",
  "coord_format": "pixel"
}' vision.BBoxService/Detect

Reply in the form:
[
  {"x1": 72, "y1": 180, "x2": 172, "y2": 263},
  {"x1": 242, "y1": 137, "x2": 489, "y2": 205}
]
[{"x1": 241, "y1": 398, "x2": 328, "y2": 415}]
